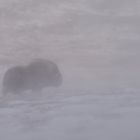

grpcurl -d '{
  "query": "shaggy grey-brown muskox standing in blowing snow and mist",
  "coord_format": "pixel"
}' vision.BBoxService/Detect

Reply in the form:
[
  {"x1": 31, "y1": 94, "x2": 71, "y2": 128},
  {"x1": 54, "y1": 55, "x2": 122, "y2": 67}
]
[{"x1": 2, "y1": 59, "x2": 62, "y2": 93}]
